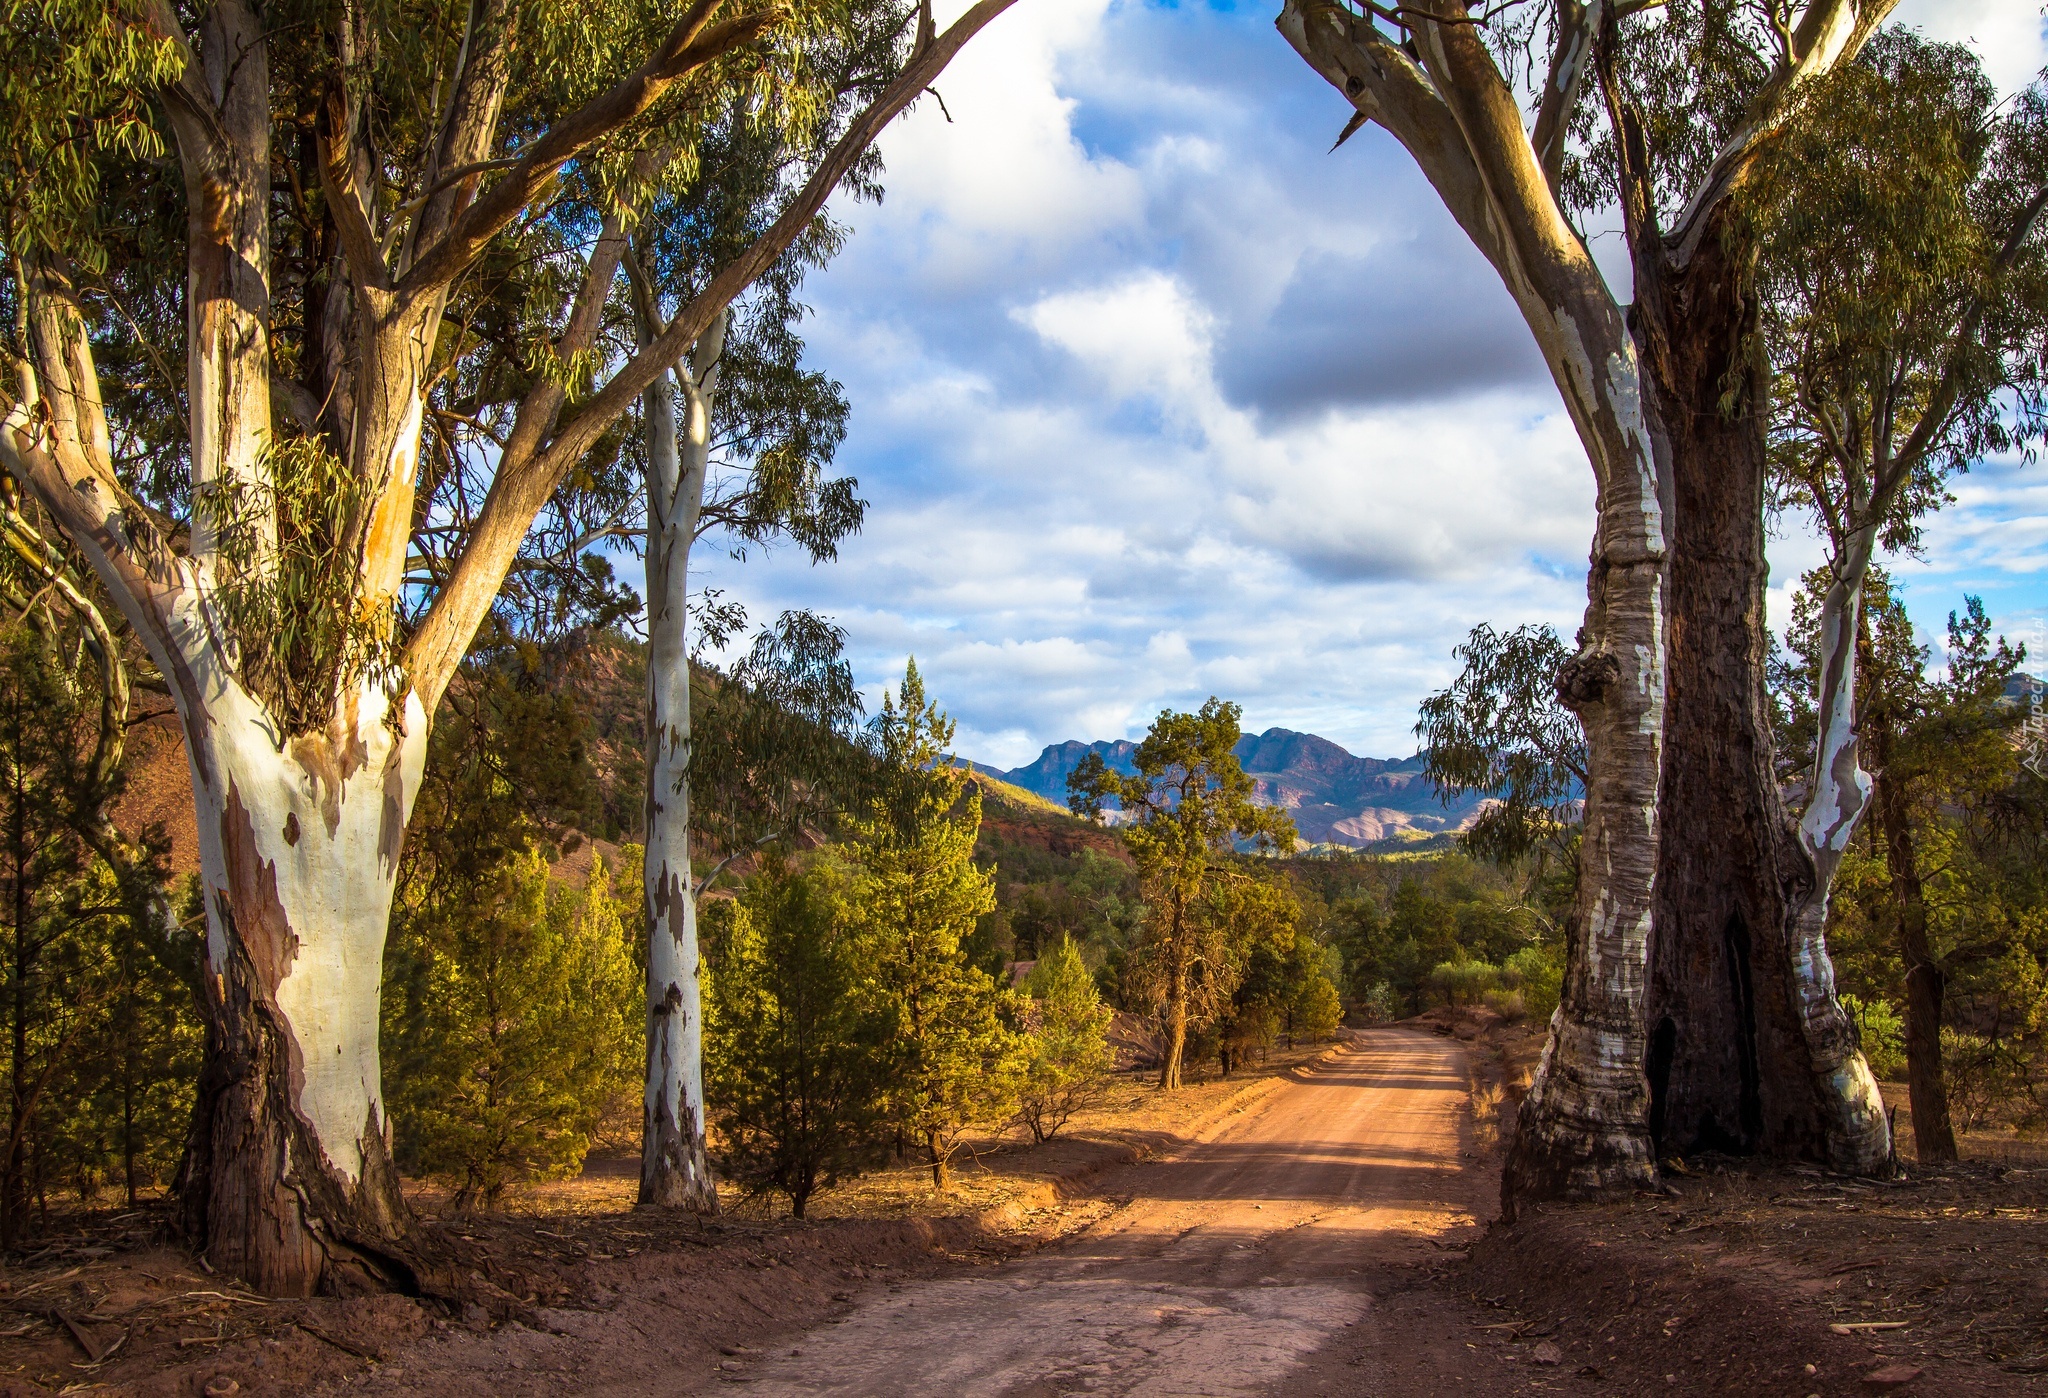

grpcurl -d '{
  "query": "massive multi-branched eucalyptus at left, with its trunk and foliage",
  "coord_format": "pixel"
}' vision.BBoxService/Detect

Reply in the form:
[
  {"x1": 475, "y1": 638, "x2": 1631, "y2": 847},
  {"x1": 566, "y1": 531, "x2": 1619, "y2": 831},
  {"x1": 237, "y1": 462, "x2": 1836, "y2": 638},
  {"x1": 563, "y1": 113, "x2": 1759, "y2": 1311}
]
[{"x1": 0, "y1": 0, "x2": 1010, "y2": 1294}]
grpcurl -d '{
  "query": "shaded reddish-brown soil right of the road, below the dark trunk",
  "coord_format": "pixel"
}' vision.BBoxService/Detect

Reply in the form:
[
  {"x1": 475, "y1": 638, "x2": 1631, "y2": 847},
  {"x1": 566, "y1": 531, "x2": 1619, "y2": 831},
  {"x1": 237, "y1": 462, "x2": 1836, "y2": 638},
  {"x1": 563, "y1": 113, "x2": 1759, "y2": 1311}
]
[{"x1": 1434, "y1": 1011, "x2": 2048, "y2": 1398}]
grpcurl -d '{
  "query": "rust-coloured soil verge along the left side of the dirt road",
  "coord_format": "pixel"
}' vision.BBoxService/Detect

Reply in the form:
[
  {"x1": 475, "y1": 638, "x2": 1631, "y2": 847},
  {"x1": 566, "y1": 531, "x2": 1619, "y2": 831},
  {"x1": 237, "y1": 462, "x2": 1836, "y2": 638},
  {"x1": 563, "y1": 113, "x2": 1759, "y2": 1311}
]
[{"x1": 0, "y1": 1046, "x2": 1325, "y2": 1398}]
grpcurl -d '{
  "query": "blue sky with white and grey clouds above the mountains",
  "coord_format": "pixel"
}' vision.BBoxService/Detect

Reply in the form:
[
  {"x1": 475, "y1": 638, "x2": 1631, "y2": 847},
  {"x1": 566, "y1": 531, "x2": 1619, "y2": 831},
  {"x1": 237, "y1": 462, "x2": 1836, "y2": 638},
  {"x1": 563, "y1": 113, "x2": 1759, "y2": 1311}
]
[{"x1": 694, "y1": 0, "x2": 2048, "y2": 766}]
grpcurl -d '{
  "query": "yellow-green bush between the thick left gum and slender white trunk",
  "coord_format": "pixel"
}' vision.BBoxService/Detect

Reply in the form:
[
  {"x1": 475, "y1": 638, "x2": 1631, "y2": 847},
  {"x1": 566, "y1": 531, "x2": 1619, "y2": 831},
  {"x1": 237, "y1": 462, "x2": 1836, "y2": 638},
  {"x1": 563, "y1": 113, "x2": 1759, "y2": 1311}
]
[{"x1": 383, "y1": 628, "x2": 643, "y2": 1208}]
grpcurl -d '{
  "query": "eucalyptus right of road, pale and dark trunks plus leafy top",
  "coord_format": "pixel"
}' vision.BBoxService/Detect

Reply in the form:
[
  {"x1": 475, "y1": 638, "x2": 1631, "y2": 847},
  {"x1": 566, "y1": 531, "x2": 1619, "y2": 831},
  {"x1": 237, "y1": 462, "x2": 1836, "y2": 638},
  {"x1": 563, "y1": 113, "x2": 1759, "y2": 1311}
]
[{"x1": 1278, "y1": 0, "x2": 1892, "y2": 1199}]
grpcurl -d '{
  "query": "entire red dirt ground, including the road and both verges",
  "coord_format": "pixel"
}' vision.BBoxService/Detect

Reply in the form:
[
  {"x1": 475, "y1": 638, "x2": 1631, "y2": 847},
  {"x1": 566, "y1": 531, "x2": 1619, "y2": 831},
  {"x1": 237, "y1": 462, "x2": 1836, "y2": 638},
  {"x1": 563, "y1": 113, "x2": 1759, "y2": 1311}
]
[{"x1": 0, "y1": 1011, "x2": 2048, "y2": 1398}]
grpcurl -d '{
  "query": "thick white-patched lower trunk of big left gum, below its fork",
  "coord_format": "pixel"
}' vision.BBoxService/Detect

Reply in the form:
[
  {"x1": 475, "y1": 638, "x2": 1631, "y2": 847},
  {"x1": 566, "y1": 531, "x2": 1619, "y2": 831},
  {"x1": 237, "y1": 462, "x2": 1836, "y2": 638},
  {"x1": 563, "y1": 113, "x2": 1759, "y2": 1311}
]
[{"x1": 174, "y1": 665, "x2": 426, "y2": 1296}]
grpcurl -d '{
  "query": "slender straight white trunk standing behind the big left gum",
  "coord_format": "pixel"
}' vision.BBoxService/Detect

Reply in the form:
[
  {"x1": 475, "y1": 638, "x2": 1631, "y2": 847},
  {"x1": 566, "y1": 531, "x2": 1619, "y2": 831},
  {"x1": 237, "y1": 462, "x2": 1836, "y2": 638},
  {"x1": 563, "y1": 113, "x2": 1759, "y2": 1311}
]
[{"x1": 639, "y1": 313, "x2": 727, "y2": 1214}]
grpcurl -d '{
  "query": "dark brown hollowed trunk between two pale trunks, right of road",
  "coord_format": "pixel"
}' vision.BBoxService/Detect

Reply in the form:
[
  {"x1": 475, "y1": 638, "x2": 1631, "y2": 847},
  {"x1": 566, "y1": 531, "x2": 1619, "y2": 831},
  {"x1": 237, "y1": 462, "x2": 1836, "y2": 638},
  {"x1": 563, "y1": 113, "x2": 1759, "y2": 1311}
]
[{"x1": 1634, "y1": 213, "x2": 1888, "y2": 1171}]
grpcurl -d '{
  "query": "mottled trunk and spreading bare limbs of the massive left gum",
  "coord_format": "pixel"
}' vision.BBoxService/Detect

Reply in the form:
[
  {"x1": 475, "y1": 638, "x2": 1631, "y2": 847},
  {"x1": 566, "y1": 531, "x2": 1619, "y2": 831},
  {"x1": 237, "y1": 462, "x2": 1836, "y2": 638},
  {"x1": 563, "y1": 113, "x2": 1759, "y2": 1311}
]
[{"x1": 0, "y1": 0, "x2": 1010, "y2": 1294}]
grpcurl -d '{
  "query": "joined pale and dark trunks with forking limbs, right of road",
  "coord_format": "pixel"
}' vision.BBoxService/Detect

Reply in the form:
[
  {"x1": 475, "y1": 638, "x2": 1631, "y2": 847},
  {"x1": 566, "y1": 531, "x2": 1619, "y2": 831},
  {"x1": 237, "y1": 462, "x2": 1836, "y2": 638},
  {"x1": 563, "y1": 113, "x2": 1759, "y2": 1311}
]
[{"x1": 1278, "y1": 0, "x2": 1890, "y2": 1212}]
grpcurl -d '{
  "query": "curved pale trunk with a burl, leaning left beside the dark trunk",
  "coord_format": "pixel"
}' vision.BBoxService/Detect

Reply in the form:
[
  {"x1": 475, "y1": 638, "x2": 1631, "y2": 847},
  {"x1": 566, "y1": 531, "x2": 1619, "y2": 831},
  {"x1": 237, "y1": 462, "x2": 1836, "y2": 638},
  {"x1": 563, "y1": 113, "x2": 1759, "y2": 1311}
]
[{"x1": 1278, "y1": 0, "x2": 1665, "y2": 1193}]
